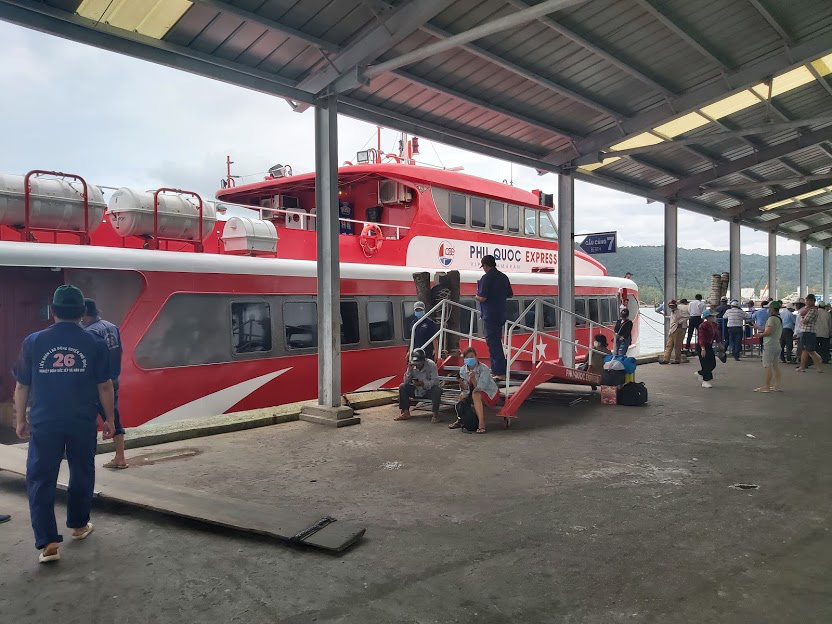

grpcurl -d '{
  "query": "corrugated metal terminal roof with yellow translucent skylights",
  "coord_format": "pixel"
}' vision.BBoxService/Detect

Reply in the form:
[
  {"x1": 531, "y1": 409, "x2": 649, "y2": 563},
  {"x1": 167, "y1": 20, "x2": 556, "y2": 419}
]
[{"x1": 0, "y1": 0, "x2": 832, "y2": 246}]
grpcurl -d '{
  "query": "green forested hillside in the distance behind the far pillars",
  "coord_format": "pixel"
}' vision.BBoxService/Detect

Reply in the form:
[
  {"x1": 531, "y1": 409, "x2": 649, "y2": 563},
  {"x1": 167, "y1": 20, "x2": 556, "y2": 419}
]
[{"x1": 598, "y1": 246, "x2": 821, "y2": 302}]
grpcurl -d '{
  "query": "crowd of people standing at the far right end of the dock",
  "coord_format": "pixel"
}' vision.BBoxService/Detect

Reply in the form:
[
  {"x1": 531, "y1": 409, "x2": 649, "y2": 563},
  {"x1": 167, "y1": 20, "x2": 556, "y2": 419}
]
[{"x1": 659, "y1": 294, "x2": 832, "y2": 392}]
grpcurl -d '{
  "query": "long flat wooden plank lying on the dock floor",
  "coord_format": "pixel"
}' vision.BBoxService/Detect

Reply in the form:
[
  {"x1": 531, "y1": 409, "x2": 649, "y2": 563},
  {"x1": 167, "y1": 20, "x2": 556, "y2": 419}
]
[{"x1": 0, "y1": 444, "x2": 366, "y2": 552}]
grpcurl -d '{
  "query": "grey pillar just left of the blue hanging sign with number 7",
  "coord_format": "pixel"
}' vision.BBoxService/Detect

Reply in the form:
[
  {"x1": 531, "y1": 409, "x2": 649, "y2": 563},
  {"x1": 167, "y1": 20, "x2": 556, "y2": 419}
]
[{"x1": 558, "y1": 173, "x2": 575, "y2": 368}]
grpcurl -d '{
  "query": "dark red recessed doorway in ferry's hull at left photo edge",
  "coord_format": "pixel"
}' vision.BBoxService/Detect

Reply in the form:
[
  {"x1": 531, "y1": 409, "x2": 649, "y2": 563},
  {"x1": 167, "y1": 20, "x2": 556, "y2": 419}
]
[{"x1": 0, "y1": 267, "x2": 64, "y2": 427}]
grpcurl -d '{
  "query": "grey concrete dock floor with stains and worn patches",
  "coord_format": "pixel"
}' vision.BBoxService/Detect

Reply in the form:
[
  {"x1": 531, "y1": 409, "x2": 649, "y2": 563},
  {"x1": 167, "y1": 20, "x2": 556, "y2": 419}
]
[{"x1": 0, "y1": 360, "x2": 832, "y2": 624}]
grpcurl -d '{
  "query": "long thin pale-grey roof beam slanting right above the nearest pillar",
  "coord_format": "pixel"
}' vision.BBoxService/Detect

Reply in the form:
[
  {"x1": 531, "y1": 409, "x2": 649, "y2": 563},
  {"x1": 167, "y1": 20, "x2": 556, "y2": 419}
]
[{"x1": 365, "y1": 0, "x2": 587, "y2": 78}]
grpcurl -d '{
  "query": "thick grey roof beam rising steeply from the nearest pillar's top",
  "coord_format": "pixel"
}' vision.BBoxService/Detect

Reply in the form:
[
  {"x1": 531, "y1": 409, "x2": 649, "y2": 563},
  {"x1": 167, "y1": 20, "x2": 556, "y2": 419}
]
[{"x1": 298, "y1": 0, "x2": 448, "y2": 105}]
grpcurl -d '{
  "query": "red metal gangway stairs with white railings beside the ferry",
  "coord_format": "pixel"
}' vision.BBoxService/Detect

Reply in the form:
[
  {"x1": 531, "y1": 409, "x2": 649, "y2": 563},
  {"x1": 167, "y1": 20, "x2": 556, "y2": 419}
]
[{"x1": 410, "y1": 297, "x2": 612, "y2": 427}]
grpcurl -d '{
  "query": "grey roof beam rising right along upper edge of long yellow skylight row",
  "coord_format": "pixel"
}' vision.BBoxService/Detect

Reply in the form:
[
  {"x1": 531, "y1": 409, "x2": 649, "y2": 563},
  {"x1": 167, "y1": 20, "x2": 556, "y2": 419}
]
[{"x1": 548, "y1": 28, "x2": 832, "y2": 165}]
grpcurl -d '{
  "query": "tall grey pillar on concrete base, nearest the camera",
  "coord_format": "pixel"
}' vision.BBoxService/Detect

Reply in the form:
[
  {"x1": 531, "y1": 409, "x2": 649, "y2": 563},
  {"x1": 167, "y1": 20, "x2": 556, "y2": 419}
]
[{"x1": 300, "y1": 95, "x2": 361, "y2": 427}]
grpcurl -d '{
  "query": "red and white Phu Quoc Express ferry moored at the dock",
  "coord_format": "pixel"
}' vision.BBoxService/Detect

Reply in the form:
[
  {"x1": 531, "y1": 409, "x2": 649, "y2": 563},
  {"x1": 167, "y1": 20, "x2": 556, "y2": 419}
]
[{"x1": 0, "y1": 144, "x2": 638, "y2": 427}]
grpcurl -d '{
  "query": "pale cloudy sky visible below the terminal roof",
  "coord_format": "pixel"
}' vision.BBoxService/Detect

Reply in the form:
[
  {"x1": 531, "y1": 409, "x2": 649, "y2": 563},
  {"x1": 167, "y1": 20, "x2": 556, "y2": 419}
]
[{"x1": 0, "y1": 22, "x2": 798, "y2": 254}]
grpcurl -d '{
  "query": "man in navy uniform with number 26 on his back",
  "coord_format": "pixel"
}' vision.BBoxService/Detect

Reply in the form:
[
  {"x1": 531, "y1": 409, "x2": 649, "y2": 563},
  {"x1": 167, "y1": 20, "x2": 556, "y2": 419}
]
[{"x1": 14, "y1": 285, "x2": 115, "y2": 563}]
